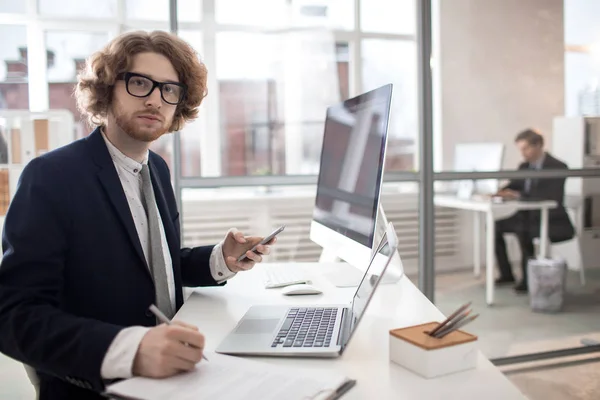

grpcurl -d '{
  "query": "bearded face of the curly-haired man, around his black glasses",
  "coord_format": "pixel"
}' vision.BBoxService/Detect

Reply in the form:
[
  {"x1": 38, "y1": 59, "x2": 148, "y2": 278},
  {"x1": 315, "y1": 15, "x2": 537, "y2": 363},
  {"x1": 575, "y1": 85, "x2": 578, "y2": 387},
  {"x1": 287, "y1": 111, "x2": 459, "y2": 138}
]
[{"x1": 110, "y1": 53, "x2": 179, "y2": 142}]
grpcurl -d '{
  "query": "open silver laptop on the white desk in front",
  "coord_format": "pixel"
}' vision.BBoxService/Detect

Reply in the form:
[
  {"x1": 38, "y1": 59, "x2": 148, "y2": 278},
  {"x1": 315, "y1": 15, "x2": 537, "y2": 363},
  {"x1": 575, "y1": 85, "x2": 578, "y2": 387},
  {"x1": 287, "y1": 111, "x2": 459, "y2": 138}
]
[{"x1": 216, "y1": 222, "x2": 398, "y2": 357}]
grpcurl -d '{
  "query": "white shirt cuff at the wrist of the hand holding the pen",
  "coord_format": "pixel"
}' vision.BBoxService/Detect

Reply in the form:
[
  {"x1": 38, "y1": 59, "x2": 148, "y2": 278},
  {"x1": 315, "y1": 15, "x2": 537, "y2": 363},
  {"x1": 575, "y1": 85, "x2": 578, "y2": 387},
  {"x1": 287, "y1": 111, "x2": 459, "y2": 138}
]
[{"x1": 100, "y1": 326, "x2": 151, "y2": 379}]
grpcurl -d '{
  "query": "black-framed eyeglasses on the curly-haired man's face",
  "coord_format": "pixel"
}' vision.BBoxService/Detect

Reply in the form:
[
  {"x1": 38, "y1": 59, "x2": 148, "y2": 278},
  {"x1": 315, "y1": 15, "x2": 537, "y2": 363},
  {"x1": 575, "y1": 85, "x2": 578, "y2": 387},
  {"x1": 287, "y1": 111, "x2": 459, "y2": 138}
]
[{"x1": 117, "y1": 72, "x2": 187, "y2": 105}]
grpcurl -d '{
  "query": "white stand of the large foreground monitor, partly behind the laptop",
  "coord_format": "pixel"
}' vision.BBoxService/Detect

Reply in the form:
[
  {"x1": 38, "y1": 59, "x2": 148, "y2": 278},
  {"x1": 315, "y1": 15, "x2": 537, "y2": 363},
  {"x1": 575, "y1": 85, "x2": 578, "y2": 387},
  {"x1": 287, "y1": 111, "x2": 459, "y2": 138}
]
[{"x1": 319, "y1": 205, "x2": 404, "y2": 287}]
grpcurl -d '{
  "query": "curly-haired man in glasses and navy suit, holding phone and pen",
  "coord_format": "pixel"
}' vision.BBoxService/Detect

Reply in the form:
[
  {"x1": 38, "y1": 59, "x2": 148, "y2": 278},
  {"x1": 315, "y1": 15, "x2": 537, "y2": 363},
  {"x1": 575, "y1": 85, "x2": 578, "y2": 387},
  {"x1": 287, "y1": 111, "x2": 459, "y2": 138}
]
[{"x1": 0, "y1": 32, "x2": 269, "y2": 400}]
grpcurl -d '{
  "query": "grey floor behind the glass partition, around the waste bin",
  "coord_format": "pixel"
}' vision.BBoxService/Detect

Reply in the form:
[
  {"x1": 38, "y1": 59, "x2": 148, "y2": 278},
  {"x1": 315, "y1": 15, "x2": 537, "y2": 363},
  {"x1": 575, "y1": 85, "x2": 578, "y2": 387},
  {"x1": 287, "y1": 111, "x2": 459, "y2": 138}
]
[{"x1": 435, "y1": 271, "x2": 600, "y2": 360}]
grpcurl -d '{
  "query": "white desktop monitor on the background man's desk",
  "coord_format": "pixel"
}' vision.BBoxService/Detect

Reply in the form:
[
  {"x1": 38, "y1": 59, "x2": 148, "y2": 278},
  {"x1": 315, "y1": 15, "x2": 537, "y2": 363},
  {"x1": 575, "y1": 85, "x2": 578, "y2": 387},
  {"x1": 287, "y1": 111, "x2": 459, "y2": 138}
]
[{"x1": 454, "y1": 143, "x2": 504, "y2": 194}]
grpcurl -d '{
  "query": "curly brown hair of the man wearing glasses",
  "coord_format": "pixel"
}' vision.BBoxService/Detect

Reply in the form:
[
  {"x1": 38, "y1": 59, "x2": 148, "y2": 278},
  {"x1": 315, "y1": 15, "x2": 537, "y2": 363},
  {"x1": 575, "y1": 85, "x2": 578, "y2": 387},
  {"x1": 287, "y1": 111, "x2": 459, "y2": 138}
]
[{"x1": 75, "y1": 31, "x2": 207, "y2": 132}]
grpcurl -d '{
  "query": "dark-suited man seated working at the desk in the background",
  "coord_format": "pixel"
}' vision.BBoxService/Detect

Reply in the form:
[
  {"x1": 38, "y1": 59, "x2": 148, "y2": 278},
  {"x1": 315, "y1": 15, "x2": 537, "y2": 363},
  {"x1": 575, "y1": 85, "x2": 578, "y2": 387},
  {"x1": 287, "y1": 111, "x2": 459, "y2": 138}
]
[{"x1": 496, "y1": 129, "x2": 575, "y2": 292}]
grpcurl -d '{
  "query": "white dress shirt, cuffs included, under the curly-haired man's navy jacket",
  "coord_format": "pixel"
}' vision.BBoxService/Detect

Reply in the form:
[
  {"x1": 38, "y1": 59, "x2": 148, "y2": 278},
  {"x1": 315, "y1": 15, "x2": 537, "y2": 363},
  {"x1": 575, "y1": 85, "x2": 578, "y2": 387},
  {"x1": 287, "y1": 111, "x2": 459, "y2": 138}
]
[{"x1": 100, "y1": 133, "x2": 235, "y2": 379}]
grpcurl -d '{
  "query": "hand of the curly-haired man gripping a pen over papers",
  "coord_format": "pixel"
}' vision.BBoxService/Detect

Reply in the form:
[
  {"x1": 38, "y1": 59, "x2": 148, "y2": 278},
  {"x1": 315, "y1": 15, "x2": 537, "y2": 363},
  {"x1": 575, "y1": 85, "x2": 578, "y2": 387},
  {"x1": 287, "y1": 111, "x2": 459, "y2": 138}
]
[{"x1": 132, "y1": 321, "x2": 204, "y2": 378}]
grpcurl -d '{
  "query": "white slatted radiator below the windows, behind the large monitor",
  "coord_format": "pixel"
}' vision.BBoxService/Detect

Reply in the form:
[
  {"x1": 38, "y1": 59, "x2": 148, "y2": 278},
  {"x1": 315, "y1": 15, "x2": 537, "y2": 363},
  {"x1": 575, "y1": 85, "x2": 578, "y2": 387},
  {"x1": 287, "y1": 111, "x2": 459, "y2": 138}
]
[{"x1": 182, "y1": 191, "x2": 460, "y2": 270}]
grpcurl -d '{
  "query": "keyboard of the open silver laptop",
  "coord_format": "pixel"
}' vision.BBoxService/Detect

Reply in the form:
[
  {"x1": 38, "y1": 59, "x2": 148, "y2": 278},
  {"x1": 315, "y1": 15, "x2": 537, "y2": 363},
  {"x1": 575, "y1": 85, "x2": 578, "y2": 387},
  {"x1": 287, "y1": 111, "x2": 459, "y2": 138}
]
[{"x1": 271, "y1": 307, "x2": 338, "y2": 347}]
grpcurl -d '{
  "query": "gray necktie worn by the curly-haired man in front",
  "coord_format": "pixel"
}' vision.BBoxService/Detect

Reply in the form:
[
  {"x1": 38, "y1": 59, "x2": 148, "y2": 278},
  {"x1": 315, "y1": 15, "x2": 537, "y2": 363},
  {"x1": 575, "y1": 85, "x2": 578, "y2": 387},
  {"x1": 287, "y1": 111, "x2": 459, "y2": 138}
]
[{"x1": 142, "y1": 165, "x2": 175, "y2": 318}]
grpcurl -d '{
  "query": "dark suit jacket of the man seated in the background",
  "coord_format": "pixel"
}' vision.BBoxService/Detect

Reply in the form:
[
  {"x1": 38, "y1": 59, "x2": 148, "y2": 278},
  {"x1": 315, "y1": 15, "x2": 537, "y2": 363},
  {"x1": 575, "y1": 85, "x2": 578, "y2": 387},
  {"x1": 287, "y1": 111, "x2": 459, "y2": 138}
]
[{"x1": 506, "y1": 153, "x2": 575, "y2": 243}]
